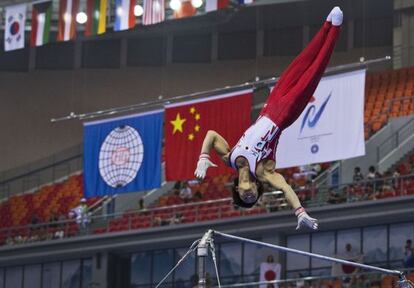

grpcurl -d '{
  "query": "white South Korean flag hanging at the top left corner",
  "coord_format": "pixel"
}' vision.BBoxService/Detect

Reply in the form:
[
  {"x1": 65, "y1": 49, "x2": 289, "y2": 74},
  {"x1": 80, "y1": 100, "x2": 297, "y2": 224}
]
[{"x1": 4, "y1": 4, "x2": 26, "y2": 51}]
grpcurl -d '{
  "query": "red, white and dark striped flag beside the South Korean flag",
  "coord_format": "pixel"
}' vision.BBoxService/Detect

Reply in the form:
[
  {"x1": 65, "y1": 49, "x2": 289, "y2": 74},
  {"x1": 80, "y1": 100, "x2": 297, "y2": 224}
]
[{"x1": 30, "y1": 1, "x2": 52, "y2": 47}]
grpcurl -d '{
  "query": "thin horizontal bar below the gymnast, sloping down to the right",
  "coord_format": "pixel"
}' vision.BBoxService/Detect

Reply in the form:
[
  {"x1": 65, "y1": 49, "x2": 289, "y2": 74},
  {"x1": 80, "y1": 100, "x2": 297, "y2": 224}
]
[{"x1": 214, "y1": 231, "x2": 403, "y2": 276}]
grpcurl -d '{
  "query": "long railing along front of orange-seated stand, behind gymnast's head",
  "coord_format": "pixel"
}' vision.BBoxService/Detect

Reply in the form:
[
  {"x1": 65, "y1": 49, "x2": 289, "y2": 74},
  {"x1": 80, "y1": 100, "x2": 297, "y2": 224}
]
[{"x1": 0, "y1": 174, "x2": 414, "y2": 245}]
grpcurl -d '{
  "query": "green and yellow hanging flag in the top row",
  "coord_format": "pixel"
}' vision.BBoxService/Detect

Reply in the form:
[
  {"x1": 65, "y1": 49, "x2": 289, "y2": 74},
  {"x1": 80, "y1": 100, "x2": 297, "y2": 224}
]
[{"x1": 85, "y1": 0, "x2": 108, "y2": 36}]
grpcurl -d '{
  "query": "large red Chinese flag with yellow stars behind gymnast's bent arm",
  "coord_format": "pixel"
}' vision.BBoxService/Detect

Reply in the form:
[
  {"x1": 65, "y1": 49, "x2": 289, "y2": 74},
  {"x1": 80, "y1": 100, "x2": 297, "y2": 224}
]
[{"x1": 165, "y1": 91, "x2": 253, "y2": 181}]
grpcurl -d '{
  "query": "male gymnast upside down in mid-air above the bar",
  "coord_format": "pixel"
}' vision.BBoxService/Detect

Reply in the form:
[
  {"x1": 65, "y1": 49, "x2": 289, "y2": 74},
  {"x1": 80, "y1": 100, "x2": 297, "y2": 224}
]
[{"x1": 194, "y1": 7, "x2": 343, "y2": 230}]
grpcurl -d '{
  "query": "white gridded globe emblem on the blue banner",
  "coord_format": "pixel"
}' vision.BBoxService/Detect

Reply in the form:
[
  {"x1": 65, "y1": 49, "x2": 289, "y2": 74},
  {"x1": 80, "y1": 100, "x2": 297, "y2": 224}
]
[{"x1": 99, "y1": 126, "x2": 144, "y2": 188}]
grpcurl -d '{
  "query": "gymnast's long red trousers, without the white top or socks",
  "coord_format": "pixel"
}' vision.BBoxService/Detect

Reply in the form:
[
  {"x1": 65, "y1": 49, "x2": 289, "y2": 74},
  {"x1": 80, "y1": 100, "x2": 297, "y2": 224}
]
[{"x1": 260, "y1": 21, "x2": 341, "y2": 130}]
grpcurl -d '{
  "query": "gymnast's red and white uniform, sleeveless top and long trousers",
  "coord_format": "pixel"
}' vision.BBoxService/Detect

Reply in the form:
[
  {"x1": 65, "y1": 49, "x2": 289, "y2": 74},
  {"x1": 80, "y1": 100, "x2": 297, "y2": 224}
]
[{"x1": 230, "y1": 21, "x2": 340, "y2": 176}]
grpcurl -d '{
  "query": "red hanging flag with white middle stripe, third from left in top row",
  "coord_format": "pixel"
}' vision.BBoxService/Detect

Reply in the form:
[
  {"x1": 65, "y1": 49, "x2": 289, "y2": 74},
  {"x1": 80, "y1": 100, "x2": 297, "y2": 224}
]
[{"x1": 57, "y1": 0, "x2": 79, "y2": 41}]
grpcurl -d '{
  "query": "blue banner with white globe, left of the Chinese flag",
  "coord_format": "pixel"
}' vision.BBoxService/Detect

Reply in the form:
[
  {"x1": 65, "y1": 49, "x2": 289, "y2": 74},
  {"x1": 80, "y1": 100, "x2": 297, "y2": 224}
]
[{"x1": 83, "y1": 110, "x2": 164, "y2": 197}]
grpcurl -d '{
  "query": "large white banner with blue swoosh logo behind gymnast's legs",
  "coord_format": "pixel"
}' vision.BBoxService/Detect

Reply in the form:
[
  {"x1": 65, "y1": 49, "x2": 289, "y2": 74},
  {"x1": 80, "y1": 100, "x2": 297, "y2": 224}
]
[{"x1": 276, "y1": 70, "x2": 365, "y2": 168}]
